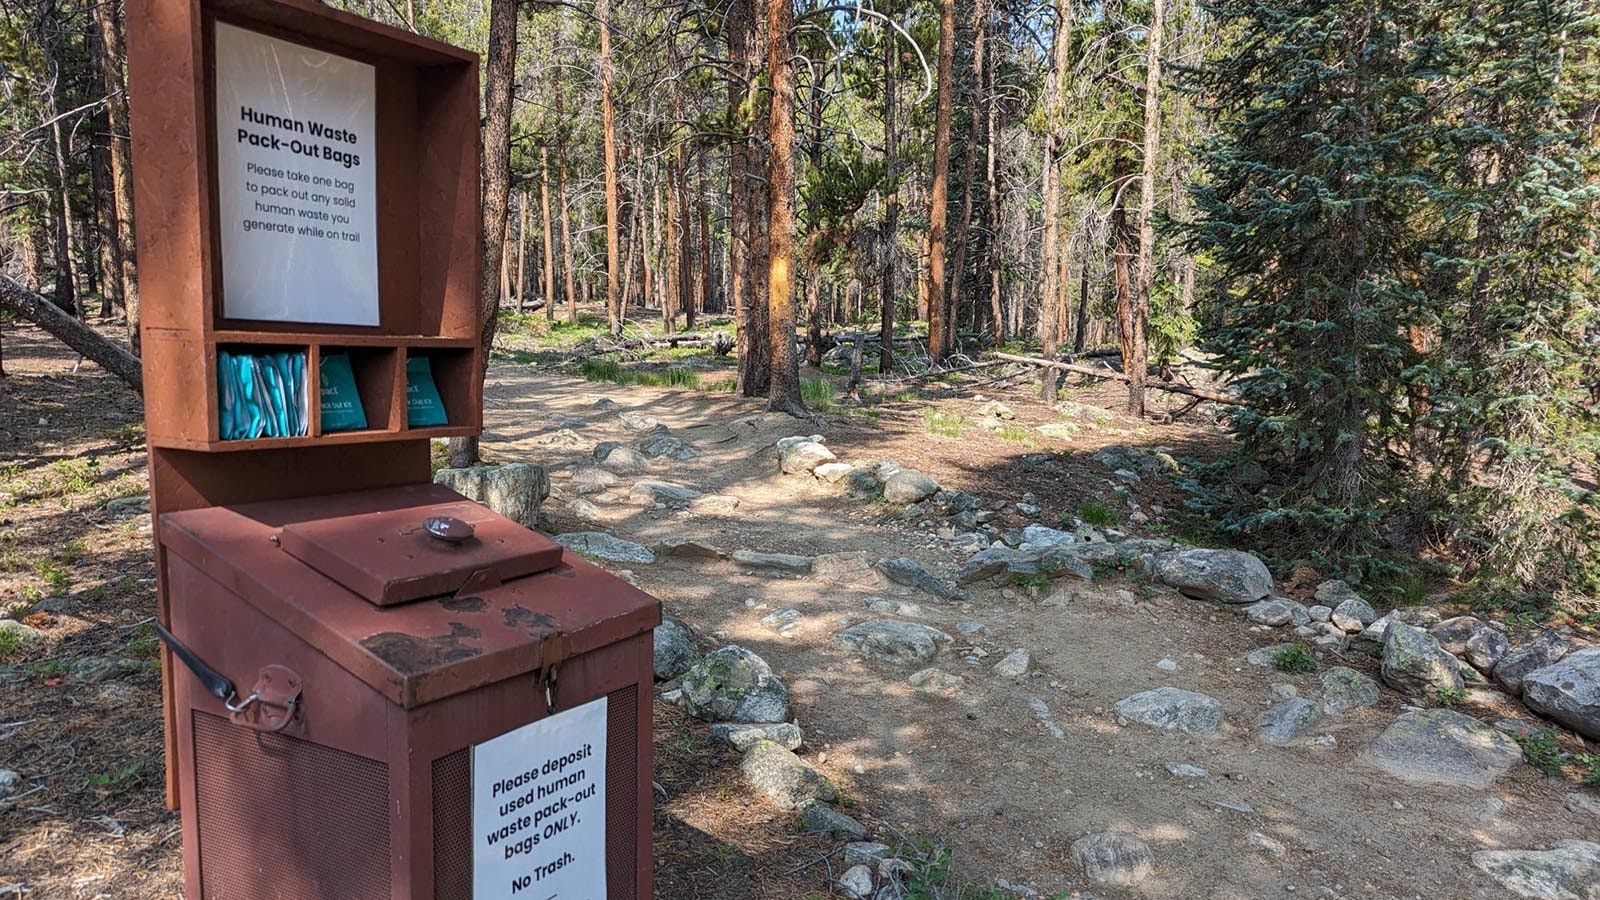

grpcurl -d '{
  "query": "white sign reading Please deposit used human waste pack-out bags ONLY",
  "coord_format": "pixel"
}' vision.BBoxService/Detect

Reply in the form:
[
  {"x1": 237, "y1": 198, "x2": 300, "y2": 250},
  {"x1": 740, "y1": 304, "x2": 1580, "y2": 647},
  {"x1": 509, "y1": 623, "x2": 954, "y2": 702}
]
[{"x1": 472, "y1": 697, "x2": 606, "y2": 900}]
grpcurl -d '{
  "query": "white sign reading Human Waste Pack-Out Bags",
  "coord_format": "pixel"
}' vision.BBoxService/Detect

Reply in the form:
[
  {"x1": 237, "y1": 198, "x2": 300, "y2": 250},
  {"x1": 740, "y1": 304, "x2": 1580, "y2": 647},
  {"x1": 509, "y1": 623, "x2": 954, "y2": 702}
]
[{"x1": 216, "y1": 22, "x2": 378, "y2": 325}]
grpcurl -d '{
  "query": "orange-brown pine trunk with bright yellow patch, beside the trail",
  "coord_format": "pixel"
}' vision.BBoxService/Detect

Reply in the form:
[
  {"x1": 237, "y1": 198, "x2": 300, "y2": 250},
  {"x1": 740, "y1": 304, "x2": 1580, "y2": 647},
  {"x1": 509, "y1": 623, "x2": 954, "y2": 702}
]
[{"x1": 766, "y1": 0, "x2": 806, "y2": 416}]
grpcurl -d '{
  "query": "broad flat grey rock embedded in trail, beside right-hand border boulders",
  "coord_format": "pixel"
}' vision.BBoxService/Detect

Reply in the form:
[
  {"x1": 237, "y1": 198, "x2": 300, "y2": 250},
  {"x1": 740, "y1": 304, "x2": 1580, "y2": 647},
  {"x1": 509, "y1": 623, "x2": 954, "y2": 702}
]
[{"x1": 1362, "y1": 709, "x2": 1522, "y2": 790}]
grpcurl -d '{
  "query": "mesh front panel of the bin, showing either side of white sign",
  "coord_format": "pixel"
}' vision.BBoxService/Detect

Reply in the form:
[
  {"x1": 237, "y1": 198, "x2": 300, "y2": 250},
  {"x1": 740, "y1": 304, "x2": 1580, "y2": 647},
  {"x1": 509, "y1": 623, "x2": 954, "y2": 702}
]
[{"x1": 434, "y1": 685, "x2": 640, "y2": 900}]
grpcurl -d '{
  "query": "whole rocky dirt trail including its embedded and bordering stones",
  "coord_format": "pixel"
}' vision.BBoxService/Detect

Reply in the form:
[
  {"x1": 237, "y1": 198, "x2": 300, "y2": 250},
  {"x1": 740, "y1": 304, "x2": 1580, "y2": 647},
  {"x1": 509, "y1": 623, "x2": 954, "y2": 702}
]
[{"x1": 485, "y1": 365, "x2": 1600, "y2": 900}]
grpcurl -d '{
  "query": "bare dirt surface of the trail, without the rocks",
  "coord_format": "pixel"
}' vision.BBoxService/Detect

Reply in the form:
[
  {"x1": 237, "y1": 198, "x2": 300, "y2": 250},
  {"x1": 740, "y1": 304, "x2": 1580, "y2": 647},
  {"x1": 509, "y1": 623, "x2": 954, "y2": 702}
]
[{"x1": 486, "y1": 360, "x2": 1594, "y2": 900}]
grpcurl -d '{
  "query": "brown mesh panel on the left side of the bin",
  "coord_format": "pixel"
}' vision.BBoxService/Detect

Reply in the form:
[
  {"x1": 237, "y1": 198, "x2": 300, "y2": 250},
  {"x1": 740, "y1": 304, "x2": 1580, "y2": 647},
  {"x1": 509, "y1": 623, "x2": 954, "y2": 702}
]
[{"x1": 194, "y1": 711, "x2": 390, "y2": 900}]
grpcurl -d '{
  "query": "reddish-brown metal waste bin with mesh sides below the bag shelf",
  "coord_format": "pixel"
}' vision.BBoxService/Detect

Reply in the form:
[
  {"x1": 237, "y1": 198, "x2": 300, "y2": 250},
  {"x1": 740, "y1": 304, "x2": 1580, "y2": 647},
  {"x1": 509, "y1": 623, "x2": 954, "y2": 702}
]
[{"x1": 158, "y1": 485, "x2": 661, "y2": 900}]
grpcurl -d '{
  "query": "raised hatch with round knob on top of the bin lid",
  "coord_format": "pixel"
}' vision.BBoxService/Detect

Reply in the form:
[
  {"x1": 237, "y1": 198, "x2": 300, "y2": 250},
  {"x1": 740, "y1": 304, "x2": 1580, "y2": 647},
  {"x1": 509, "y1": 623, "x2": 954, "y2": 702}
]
[{"x1": 278, "y1": 488, "x2": 562, "y2": 605}]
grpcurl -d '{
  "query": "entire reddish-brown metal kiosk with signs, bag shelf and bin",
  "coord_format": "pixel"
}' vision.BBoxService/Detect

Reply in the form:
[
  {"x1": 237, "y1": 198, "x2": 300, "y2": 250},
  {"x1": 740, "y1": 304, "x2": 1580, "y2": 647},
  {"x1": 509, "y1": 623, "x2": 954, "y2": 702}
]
[{"x1": 126, "y1": 0, "x2": 661, "y2": 900}]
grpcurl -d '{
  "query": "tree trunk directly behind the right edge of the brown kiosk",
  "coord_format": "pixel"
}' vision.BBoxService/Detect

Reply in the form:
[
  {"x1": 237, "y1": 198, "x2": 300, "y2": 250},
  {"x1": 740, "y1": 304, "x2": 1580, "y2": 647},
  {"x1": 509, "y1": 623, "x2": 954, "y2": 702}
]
[{"x1": 450, "y1": 0, "x2": 517, "y2": 469}]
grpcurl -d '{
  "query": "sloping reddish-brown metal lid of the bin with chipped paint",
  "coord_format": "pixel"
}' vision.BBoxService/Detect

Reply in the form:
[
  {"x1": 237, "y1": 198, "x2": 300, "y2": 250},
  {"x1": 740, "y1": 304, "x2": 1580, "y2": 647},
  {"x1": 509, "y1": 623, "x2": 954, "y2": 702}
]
[{"x1": 158, "y1": 485, "x2": 661, "y2": 708}]
